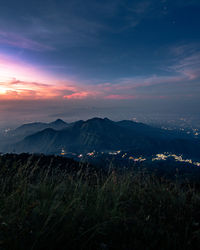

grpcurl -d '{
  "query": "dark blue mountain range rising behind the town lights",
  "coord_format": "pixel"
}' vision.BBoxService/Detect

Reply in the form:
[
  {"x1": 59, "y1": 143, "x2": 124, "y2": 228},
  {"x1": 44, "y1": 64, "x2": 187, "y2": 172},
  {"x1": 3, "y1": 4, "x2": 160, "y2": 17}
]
[{"x1": 4, "y1": 118, "x2": 200, "y2": 158}]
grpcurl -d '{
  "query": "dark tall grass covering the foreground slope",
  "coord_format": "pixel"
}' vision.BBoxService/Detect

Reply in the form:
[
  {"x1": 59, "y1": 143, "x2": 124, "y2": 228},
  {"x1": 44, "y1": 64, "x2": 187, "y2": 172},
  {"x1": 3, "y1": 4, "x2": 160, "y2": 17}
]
[{"x1": 0, "y1": 153, "x2": 200, "y2": 250}]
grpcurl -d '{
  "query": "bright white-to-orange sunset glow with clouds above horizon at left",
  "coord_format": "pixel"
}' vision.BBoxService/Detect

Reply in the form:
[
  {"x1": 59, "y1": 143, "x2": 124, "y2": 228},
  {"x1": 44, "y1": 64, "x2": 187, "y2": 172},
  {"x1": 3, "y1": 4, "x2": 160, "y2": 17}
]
[{"x1": 0, "y1": 53, "x2": 100, "y2": 100}]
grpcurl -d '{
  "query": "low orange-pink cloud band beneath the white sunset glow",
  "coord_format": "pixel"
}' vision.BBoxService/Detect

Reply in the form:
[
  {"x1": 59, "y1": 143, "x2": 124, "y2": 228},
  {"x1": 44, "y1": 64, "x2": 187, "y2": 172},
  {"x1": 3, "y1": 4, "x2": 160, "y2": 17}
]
[{"x1": 0, "y1": 76, "x2": 101, "y2": 100}]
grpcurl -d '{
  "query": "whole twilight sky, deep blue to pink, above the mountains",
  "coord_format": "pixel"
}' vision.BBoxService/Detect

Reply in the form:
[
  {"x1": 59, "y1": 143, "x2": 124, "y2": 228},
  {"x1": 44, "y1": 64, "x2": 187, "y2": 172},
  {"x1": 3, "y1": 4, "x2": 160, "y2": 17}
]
[{"x1": 0, "y1": 0, "x2": 200, "y2": 126}]
